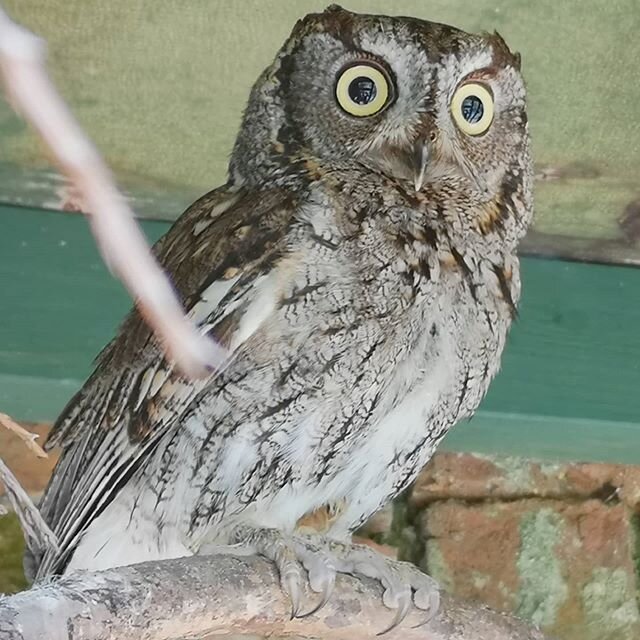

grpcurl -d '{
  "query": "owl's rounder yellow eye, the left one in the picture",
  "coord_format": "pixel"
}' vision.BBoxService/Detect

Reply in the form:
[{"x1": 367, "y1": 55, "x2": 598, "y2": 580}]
[{"x1": 336, "y1": 63, "x2": 392, "y2": 118}]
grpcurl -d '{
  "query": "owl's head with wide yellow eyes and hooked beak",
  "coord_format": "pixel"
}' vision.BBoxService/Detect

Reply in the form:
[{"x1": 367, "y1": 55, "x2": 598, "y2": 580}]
[{"x1": 231, "y1": 5, "x2": 530, "y2": 208}]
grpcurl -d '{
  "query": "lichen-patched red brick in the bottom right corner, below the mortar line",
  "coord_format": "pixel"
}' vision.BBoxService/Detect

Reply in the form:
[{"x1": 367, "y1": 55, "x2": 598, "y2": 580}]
[{"x1": 421, "y1": 499, "x2": 640, "y2": 640}]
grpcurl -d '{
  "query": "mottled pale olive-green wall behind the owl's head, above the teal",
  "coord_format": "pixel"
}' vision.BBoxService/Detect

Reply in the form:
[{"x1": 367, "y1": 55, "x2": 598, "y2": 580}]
[{"x1": 0, "y1": 0, "x2": 640, "y2": 263}]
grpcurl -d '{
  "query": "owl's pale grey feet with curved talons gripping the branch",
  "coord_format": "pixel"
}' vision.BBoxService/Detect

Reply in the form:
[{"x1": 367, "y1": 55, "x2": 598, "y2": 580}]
[{"x1": 226, "y1": 526, "x2": 440, "y2": 635}]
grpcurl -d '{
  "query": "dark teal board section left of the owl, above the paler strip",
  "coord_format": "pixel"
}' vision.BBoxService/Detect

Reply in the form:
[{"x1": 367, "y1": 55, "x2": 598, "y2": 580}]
[{"x1": 0, "y1": 207, "x2": 168, "y2": 379}]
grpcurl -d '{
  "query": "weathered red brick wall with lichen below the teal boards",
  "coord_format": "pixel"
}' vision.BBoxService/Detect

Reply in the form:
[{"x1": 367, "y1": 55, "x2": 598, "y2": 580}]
[{"x1": 0, "y1": 427, "x2": 640, "y2": 640}]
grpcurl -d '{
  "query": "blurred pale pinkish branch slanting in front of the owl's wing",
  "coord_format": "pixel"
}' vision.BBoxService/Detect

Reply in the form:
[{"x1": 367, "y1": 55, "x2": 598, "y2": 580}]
[{"x1": 0, "y1": 8, "x2": 226, "y2": 376}]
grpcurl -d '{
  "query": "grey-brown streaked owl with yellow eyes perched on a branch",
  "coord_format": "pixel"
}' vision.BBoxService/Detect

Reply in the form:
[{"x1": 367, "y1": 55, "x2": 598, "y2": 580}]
[{"x1": 28, "y1": 5, "x2": 532, "y2": 626}]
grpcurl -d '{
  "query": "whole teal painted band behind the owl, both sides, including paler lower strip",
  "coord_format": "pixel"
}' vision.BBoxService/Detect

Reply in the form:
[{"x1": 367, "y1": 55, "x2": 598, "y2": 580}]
[{"x1": 0, "y1": 207, "x2": 640, "y2": 462}]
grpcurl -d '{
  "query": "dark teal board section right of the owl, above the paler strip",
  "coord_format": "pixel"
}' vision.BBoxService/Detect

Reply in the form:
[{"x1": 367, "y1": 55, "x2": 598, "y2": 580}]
[{"x1": 483, "y1": 258, "x2": 640, "y2": 423}]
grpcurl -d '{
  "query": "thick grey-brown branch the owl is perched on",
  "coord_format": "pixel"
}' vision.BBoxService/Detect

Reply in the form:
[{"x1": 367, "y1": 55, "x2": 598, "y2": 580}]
[{"x1": 0, "y1": 556, "x2": 544, "y2": 640}]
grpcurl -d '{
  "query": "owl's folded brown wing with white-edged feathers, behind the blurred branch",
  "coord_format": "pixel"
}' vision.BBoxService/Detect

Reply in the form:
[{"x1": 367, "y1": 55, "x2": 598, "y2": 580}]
[{"x1": 32, "y1": 182, "x2": 296, "y2": 577}]
